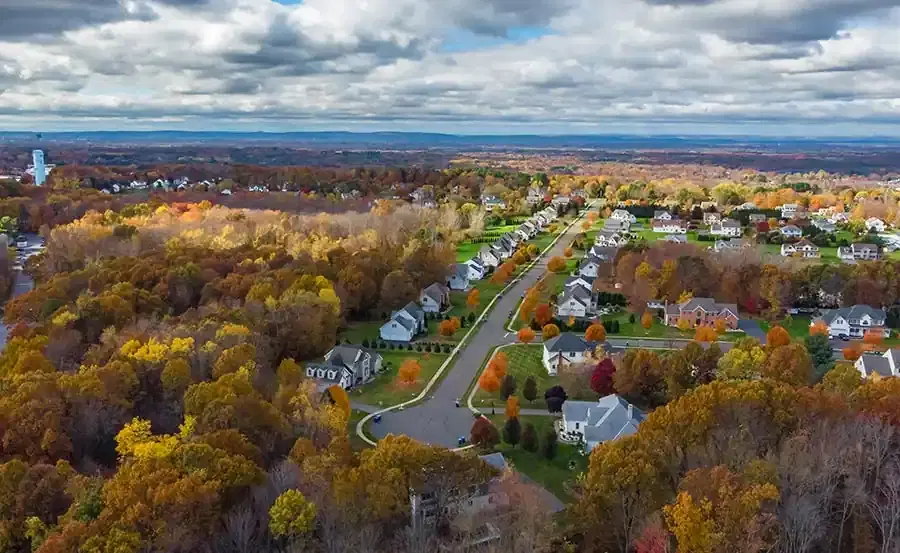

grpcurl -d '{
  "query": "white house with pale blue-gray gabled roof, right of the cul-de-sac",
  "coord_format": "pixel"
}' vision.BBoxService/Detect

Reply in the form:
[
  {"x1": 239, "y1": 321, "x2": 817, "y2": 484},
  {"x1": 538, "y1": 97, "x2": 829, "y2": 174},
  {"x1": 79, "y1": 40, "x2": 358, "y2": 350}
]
[{"x1": 561, "y1": 394, "x2": 647, "y2": 451}]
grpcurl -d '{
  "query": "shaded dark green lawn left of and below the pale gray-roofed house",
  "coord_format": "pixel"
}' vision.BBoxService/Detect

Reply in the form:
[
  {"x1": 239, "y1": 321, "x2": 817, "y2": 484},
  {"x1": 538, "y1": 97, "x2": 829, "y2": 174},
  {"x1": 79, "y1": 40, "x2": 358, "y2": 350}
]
[{"x1": 489, "y1": 415, "x2": 589, "y2": 503}]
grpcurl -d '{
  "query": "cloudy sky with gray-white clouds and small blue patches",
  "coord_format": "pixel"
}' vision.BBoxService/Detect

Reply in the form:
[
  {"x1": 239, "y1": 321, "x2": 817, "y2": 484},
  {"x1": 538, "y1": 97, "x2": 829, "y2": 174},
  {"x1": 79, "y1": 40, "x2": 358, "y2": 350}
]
[{"x1": 0, "y1": 0, "x2": 900, "y2": 136}]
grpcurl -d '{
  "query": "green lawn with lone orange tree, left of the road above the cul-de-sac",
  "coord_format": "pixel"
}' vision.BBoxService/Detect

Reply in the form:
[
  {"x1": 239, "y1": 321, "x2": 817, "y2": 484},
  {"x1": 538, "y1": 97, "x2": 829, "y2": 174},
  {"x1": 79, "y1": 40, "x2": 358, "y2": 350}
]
[{"x1": 350, "y1": 350, "x2": 448, "y2": 407}]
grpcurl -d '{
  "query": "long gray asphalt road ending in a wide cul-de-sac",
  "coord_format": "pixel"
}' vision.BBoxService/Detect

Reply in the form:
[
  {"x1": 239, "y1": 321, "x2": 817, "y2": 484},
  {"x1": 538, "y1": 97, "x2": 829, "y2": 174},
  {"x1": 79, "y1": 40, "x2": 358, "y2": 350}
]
[{"x1": 369, "y1": 208, "x2": 588, "y2": 448}]
